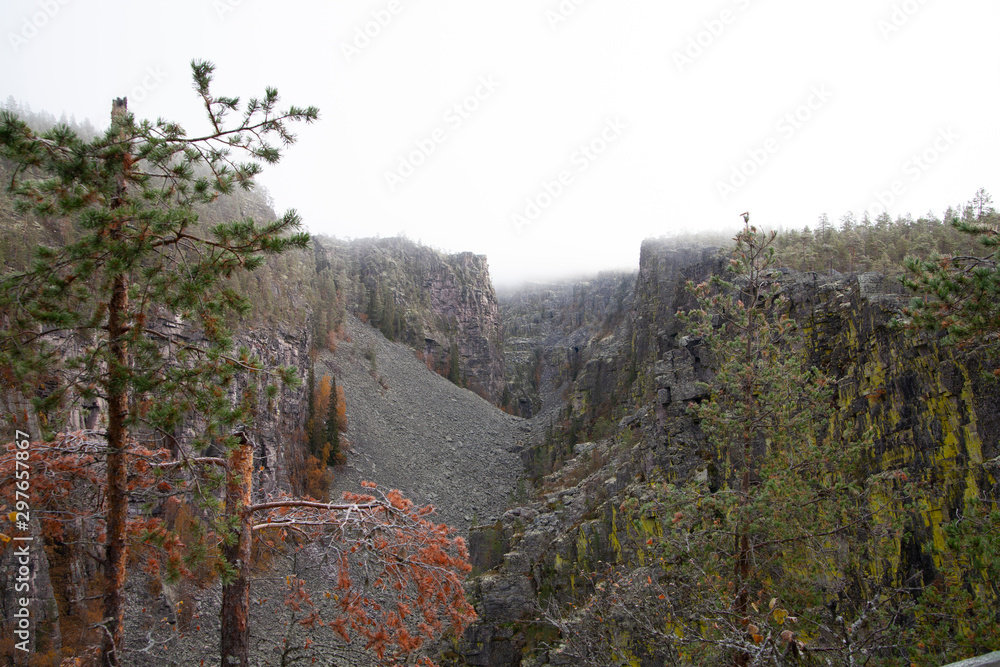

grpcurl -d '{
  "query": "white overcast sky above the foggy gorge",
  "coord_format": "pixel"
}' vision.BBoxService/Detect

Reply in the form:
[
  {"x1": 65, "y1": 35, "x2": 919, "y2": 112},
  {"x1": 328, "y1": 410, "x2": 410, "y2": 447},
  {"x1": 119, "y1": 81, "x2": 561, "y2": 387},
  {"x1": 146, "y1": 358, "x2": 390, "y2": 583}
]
[{"x1": 0, "y1": 0, "x2": 1000, "y2": 284}]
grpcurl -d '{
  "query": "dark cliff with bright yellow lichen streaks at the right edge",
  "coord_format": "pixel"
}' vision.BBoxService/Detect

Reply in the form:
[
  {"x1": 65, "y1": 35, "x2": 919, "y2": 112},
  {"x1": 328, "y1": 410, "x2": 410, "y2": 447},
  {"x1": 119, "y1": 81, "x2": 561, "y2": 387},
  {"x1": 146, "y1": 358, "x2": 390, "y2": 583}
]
[{"x1": 789, "y1": 274, "x2": 1000, "y2": 582}]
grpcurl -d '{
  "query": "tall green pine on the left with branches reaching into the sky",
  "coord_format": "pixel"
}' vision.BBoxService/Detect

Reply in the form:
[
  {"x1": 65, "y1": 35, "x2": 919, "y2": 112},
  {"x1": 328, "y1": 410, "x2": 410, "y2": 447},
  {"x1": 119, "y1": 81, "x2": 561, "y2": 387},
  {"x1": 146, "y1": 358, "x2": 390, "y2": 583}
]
[{"x1": 0, "y1": 61, "x2": 318, "y2": 665}]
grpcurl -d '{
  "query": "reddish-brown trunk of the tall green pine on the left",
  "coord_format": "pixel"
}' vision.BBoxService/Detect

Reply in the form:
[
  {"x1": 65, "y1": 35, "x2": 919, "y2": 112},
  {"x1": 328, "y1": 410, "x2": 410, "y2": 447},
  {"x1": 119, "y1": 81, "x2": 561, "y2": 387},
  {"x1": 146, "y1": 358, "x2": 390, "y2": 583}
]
[{"x1": 101, "y1": 99, "x2": 129, "y2": 667}]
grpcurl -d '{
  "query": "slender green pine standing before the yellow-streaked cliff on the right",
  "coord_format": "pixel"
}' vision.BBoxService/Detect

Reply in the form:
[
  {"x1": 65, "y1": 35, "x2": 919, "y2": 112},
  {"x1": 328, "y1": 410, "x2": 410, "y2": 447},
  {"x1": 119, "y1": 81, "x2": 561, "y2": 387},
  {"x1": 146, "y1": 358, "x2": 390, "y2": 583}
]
[{"x1": 663, "y1": 225, "x2": 884, "y2": 665}]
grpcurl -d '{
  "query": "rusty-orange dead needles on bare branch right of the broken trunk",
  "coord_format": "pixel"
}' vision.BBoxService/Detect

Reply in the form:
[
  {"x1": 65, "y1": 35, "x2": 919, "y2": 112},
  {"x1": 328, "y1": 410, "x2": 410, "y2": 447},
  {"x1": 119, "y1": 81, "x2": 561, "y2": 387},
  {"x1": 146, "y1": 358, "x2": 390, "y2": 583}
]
[{"x1": 264, "y1": 482, "x2": 475, "y2": 665}]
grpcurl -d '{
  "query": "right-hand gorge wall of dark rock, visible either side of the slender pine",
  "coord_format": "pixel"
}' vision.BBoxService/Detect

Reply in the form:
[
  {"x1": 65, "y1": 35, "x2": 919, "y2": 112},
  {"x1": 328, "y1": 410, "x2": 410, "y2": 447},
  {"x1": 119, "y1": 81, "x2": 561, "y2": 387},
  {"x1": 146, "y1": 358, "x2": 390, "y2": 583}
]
[{"x1": 451, "y1": 242, "x2": 1000, "y2": 665}]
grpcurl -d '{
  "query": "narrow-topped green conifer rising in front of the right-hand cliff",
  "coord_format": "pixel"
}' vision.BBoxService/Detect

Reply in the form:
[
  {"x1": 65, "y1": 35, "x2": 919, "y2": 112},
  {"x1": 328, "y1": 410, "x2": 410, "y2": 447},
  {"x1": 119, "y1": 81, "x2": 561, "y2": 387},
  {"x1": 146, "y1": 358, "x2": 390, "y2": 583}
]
[{"x1": 678, "y1": 225, "x2": 841, "y2": 665}]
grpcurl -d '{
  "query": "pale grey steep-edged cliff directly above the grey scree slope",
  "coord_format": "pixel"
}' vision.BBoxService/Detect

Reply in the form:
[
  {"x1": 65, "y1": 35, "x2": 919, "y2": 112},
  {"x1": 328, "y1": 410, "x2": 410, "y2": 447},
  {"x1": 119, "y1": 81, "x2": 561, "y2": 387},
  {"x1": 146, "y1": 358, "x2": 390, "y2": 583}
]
[{"x1": 316, "y1": 238, "x2": 504, "y2": 404}]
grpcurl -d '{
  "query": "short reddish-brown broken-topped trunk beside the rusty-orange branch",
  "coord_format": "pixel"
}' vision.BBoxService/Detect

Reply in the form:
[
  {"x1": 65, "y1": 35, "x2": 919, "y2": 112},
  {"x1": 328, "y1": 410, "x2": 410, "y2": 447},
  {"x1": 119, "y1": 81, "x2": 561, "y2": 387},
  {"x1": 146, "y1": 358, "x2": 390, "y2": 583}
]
[{"x1": 220, "y1": 433, "x2": 253, "y2": 667}]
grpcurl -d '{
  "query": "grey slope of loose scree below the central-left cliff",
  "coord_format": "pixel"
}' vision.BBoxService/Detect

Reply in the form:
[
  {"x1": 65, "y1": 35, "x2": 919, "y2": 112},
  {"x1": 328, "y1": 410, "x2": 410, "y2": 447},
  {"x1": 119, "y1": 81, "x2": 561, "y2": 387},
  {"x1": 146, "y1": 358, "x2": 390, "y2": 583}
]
[{"x1": 315, "y1": 317, "x2": 531, "y2": 534}]
